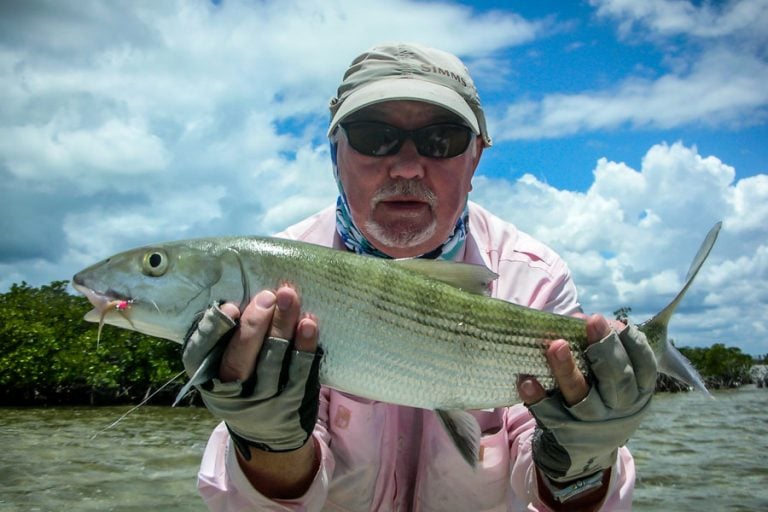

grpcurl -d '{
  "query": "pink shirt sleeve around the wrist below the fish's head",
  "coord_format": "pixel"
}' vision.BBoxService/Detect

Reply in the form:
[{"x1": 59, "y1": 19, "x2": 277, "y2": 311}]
[{"x1": 197, "y1": 388, "x2": 334, "y2": 512}]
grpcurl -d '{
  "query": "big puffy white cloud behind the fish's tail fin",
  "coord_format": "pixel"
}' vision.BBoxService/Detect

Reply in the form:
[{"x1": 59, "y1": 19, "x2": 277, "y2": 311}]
[{"x1": 473, "y1": 143, "x2": 768, "y2": 352}]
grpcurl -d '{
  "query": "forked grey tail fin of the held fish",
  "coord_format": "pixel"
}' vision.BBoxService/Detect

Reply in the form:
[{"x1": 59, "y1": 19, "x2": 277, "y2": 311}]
[{"x1": 639, "y1": 222, "x2": 722, "y2": 397}]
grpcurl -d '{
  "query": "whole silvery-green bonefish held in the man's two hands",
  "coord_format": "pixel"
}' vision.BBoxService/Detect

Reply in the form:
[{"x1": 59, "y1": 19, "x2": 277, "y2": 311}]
[{"x1": 73, "y1": 223, "x2": 721, "y2": 460}]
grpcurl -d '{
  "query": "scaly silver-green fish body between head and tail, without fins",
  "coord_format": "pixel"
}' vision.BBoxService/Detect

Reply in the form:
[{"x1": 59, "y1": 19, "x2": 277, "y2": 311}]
[{"x1": 247, "y1": 242, "x2": 585, "y2": 409}]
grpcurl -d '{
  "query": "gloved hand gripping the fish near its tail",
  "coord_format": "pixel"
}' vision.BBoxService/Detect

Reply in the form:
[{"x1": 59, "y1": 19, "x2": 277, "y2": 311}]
[{"x1": 518, "y1": 315, "x2": 656, "y2": 504}]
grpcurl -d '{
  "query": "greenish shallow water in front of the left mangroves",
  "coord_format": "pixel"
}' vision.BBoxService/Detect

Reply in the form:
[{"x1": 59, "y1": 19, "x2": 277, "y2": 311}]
[{"x1": 0, "y1": 407, "x2": 217, "y2": 512}]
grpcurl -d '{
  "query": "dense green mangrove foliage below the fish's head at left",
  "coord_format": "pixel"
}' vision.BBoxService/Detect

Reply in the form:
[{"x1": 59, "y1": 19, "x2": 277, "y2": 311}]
[{"x1": 0, "y1": 281, "x2": 182, "y2": 404}]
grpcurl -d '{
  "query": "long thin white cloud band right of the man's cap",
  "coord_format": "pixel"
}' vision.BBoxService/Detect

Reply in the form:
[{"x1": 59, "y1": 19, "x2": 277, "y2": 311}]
[{"x1": 494, "y1": 48, "x2": 768, "y2": 140}]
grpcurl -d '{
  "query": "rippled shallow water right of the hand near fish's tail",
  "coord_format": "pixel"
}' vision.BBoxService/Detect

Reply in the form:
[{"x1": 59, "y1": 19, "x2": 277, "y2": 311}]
[{"x1": 629, "y1": 386, "x2": 768, "y2": 512}]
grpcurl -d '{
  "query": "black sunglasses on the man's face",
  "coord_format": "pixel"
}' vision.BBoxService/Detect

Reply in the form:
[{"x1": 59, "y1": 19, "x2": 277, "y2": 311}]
[{"x1": 341, "y1": 121, "x2": 474, "y2": 158}]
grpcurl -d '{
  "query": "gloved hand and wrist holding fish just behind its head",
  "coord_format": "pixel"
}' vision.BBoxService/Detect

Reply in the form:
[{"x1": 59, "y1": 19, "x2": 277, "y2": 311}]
[{"x1": 182, "y1": 286, "x2": 321, "y2": 498}]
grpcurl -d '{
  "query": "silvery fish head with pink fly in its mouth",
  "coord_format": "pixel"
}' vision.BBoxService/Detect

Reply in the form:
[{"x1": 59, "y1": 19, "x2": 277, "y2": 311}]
[{"x1": 72, "y1": 241, "x2": 232, "y2": 343}]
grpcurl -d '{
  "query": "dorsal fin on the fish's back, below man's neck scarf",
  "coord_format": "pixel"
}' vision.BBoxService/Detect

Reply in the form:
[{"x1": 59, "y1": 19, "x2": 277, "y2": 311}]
[{"x1": 394, "y1": 258, "x2": 499, "y2": 295}]
